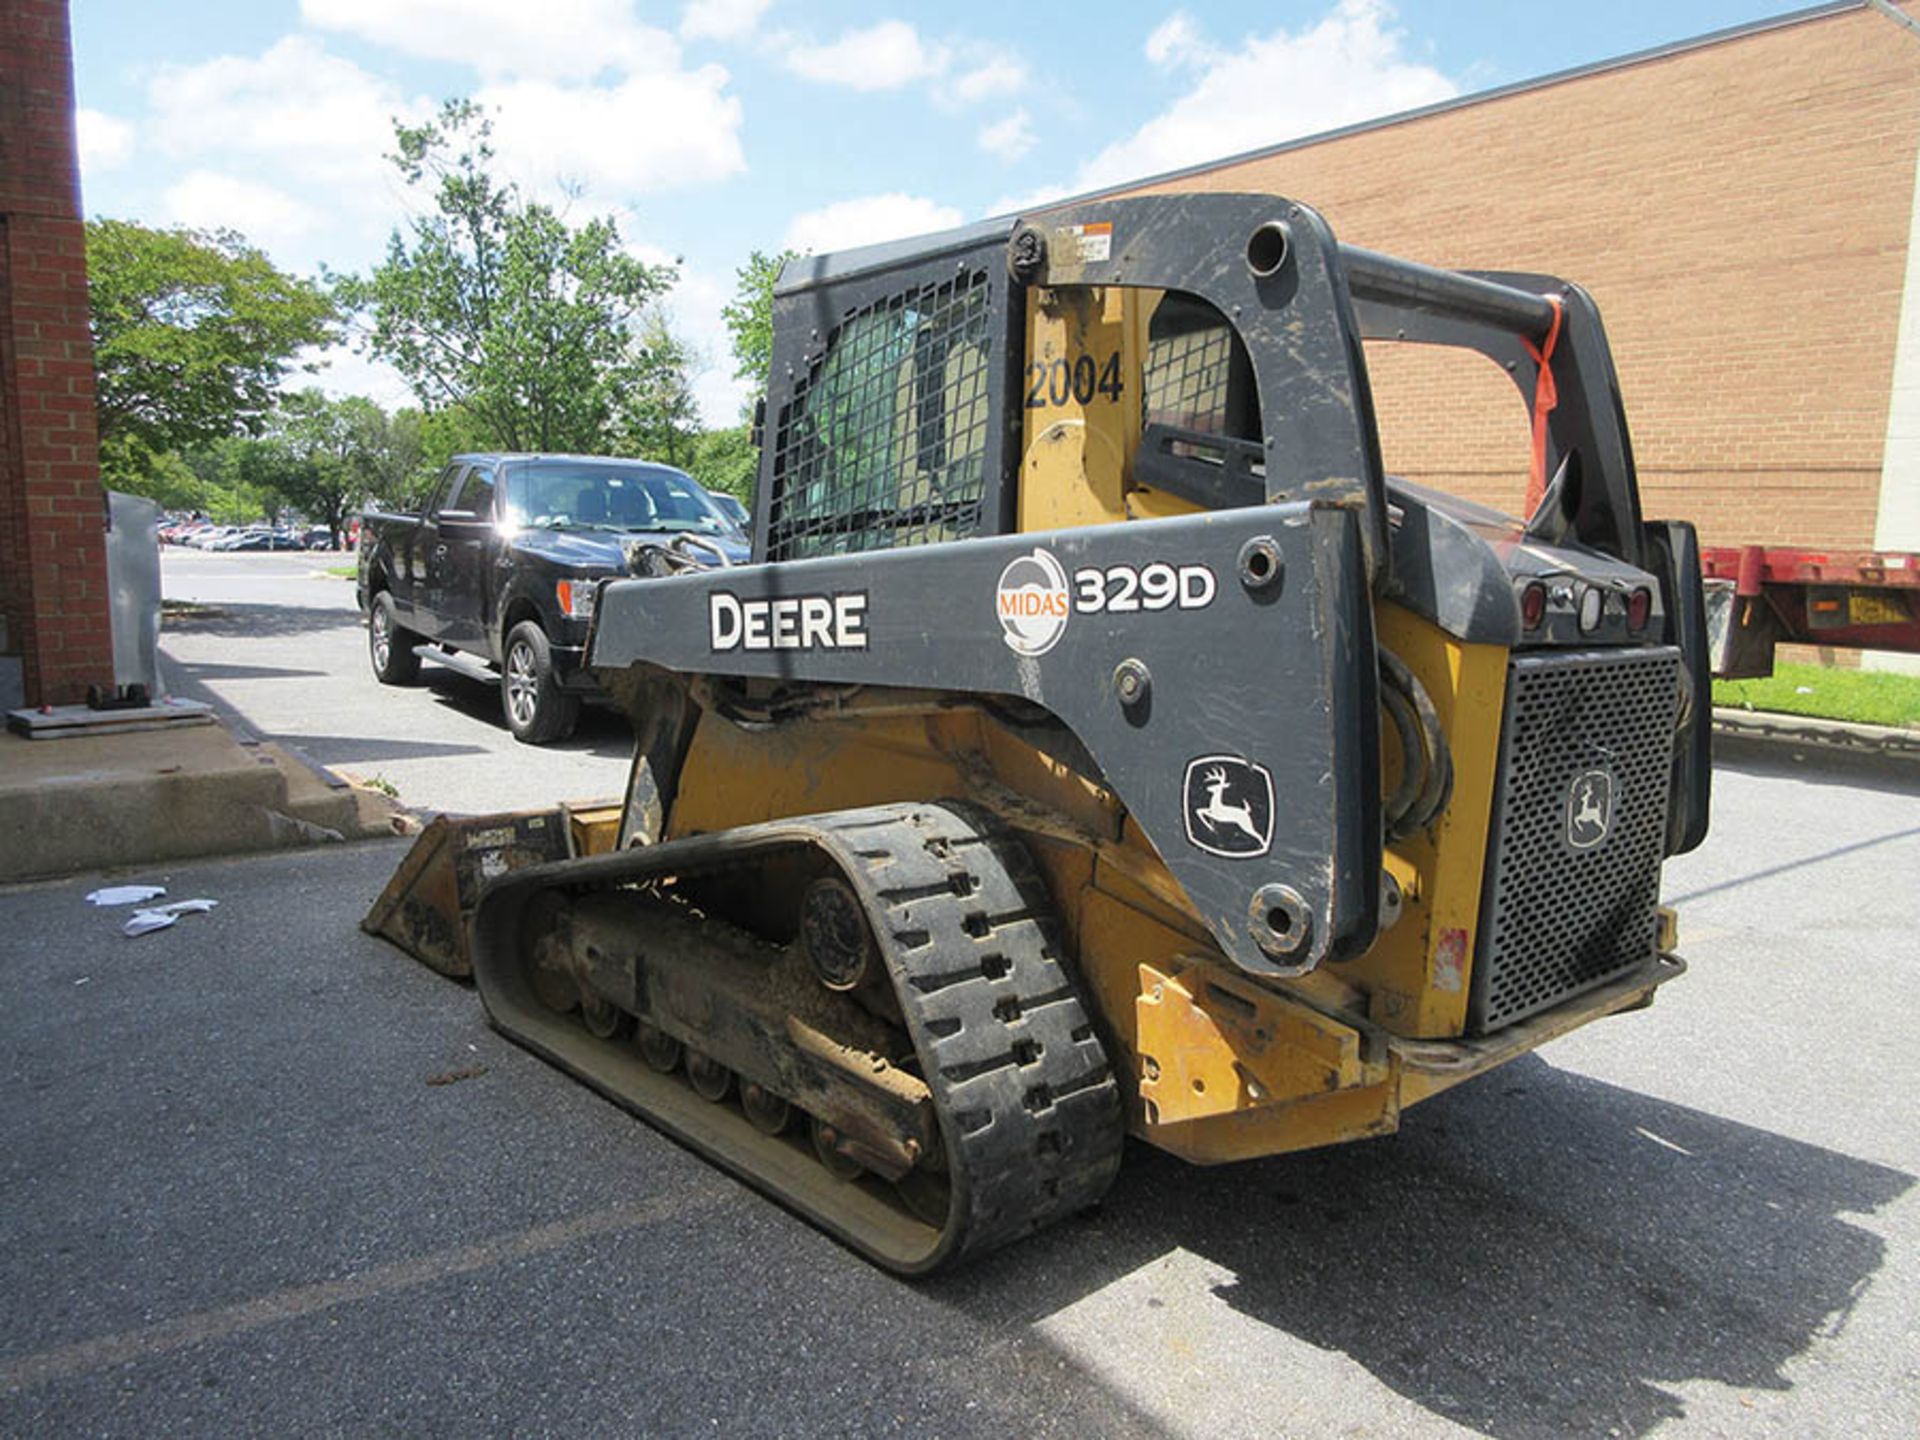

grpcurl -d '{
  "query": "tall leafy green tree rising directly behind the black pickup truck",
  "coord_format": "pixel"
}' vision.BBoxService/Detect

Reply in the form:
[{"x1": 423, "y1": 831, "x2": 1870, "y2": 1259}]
[{"x1": 334, "y1": 100, "x2": 676, "y2": 451}]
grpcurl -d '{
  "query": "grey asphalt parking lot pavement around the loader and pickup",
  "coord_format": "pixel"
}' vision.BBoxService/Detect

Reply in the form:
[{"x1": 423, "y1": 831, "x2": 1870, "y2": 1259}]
[{"x1": 0, "y1": 553, "x2": 1920, "y2": 1436}]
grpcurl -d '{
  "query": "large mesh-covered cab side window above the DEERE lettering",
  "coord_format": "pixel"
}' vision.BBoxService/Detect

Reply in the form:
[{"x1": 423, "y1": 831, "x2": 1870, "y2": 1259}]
[{"x1": 768, "y1": 271, "x2": 991, "y2": 561}]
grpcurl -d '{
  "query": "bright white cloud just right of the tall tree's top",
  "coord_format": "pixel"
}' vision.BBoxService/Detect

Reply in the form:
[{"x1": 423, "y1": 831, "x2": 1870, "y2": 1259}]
[{"x1": 474, "y1": 65, "x2": 747, "y2": 201}]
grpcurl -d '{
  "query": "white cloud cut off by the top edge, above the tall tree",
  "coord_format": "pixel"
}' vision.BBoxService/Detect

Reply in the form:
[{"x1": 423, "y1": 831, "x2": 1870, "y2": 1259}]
[{"x1": 300, "y1": 0, "x2": 680, "y2": 79}]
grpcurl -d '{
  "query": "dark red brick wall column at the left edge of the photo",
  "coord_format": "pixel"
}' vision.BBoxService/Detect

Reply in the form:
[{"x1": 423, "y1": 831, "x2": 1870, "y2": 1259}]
[{"x1": 0, "y1": 0, "x2": 113, "y2": 705}]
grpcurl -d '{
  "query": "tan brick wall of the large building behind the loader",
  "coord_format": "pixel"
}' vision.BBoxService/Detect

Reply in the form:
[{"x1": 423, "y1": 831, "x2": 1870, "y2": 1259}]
[{"x1": 1121, "y1": 10, "x2": 1920, "y2": 547}]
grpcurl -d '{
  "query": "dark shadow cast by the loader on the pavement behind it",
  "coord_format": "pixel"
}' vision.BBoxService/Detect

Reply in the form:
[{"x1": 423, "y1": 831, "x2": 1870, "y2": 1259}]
[{"x1": 939, "y1": 1056, "x2": 1914, "y2": 1438}]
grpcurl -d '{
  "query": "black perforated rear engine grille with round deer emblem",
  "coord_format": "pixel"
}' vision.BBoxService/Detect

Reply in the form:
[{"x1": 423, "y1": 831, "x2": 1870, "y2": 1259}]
[{"x1": 1467, "y1": 647, "x2": 1680, "y2": 1033}]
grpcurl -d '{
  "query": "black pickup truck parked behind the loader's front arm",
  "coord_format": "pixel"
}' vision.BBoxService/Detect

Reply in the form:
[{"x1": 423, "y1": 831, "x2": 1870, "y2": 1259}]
[{"x1": 357, "y1": 455, "x2": 749, "y2": 745}]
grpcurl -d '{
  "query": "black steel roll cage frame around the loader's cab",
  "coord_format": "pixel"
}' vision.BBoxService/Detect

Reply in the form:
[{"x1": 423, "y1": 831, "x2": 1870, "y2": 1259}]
[{"x1": 755, "y1": 194, "x2": 1644, "y2": 588}]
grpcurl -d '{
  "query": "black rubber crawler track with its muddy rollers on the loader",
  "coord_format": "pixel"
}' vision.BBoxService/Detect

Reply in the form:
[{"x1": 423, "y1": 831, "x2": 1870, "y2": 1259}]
[{"x1": 474, "y1": 803, "x2": 1123, "y2": 1275}]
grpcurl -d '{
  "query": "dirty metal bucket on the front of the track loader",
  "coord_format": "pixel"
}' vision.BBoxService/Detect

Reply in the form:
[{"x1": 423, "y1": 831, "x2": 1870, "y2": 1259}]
[{"x1": 361, "y1": 803, "x2": 620, "y2": 977}]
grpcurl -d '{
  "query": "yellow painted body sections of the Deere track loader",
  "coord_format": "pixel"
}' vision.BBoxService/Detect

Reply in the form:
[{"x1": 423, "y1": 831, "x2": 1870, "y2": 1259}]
[{"x1": 629, "y1": 286, "x2": 1678, "y2": 1164}]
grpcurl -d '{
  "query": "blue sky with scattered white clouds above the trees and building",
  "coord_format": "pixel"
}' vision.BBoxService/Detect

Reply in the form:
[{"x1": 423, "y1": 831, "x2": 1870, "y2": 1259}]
[{"x1": 71, "y1": 0, "x2": 1799, "y2": 424}]
